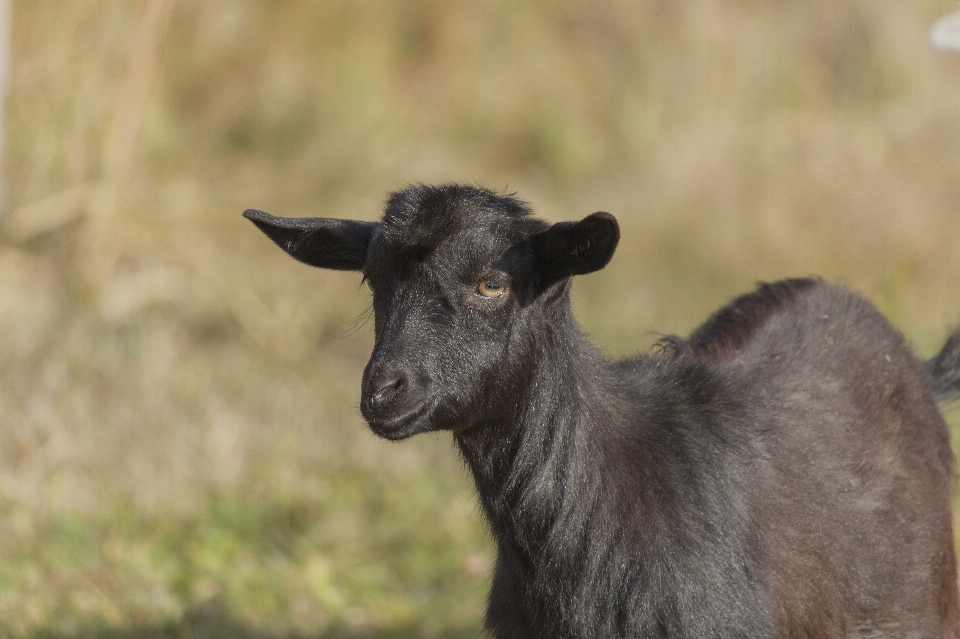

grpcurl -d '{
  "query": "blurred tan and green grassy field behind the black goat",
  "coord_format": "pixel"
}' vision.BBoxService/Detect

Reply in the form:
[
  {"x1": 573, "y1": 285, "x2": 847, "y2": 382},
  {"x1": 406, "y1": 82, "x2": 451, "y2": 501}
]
[{"x1": 0, "y1": 0, "x2": 960, "y2": 639}]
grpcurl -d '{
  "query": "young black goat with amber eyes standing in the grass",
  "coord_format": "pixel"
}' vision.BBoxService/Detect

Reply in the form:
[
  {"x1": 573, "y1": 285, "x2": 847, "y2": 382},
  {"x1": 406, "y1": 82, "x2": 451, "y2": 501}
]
[{"x1": 244, "y1": 185, "x2": 960, "y2": 639}]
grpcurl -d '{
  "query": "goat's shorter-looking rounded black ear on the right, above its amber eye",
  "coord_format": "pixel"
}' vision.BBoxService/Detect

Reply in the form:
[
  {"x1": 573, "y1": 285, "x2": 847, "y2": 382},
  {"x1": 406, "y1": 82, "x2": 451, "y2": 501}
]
[{"x1": 530, "y1": 212, "x2": 620, "y2": 291}]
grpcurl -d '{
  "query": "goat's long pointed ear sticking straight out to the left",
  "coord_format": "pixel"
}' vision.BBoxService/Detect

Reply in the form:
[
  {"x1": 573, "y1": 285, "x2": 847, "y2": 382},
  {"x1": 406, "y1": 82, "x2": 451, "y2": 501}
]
[{"x1": 243, "y1": 209, "x2": 377, "y2": 271}]
